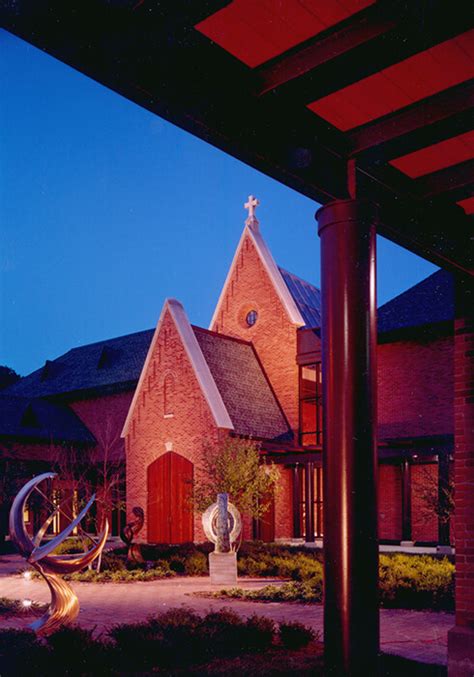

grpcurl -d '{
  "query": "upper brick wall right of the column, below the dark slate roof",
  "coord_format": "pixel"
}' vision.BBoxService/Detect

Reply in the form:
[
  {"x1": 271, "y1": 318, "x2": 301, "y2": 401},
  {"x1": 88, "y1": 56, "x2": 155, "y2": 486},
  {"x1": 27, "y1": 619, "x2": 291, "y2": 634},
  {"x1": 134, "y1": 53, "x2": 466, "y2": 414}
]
[{"x1": 377, "y1": 336, "x2": 454, "y2": 439}]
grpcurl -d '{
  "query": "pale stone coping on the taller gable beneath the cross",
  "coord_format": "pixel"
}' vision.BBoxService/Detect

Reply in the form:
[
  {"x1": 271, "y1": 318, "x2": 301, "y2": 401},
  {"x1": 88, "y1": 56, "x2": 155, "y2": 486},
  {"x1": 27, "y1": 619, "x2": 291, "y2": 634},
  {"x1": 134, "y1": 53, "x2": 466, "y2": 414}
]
[{"x1": 209, "y1": 225, "x2": 305, "y2": 328}]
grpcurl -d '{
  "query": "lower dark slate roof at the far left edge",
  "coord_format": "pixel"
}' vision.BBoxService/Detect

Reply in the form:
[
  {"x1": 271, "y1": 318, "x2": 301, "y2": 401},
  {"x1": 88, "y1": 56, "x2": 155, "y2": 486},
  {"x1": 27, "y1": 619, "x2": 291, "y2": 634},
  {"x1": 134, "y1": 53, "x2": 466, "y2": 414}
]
[{"x1": 0, "y1": 394, "x2": 96, "y2": 444}]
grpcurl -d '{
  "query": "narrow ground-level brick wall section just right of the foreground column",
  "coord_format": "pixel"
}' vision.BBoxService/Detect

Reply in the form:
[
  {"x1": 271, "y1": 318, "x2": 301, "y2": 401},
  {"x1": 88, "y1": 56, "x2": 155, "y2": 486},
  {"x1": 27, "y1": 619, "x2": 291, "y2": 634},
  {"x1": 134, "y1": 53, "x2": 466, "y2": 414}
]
[{"x1": 379, "y1": 464, "x2": 402, "y2": 541}]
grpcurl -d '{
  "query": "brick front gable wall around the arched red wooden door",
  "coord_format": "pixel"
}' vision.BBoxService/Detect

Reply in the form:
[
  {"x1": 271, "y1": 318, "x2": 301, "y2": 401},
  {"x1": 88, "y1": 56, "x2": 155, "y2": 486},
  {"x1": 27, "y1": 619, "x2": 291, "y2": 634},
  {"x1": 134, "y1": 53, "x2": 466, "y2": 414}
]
[{"x1": 126, "y1": 311, "x2": 219, "y2": 541}]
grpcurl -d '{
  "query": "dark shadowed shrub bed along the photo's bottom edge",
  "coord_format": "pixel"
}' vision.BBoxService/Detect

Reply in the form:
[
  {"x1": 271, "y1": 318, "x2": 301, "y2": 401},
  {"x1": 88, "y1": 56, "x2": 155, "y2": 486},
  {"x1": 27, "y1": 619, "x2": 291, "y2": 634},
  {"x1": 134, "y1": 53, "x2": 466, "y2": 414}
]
[{"x1": 0, "y1": 608, "x2": 446, "y2": 677}]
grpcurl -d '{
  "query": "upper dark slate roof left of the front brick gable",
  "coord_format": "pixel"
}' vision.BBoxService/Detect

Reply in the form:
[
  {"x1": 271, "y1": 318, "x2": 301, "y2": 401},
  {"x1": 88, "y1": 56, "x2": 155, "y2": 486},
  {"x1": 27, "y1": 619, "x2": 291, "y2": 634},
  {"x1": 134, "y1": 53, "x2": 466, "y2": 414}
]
[{"x1": 4, "y1": 329, "x2": 153, "y2": 397}]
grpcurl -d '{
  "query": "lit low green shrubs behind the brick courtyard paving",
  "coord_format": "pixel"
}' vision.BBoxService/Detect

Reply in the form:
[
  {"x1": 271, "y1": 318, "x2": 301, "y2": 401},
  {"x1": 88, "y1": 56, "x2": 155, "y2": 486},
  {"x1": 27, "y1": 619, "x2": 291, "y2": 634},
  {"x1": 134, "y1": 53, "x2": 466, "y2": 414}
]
[{"x1": 19, "y1": 539, "x2": 454, "y2": 611}]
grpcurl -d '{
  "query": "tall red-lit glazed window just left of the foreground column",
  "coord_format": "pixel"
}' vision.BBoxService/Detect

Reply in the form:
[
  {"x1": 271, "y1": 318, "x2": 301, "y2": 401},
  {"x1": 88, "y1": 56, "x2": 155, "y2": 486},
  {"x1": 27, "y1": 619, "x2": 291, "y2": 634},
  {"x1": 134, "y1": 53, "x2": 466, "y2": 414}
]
[{"x1": 299, "y1": 362, "x2": 323, "y2": 446}]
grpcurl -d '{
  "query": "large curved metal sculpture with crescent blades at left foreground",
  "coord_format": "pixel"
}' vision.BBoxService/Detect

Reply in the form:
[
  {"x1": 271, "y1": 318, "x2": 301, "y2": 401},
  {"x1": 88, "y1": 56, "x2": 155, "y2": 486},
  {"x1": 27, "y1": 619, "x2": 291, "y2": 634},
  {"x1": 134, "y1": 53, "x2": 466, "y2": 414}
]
[{"x1": 9, "y1": 472, "x2": 109, "y2": 635}]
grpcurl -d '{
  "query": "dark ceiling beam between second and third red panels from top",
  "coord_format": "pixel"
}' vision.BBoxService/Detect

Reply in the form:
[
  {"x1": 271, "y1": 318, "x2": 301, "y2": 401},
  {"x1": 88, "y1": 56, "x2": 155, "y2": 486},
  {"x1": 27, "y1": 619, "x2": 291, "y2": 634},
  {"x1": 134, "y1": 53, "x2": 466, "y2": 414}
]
[{"x1": 347, "y1": 79, "x2": 474, "y2": 162}]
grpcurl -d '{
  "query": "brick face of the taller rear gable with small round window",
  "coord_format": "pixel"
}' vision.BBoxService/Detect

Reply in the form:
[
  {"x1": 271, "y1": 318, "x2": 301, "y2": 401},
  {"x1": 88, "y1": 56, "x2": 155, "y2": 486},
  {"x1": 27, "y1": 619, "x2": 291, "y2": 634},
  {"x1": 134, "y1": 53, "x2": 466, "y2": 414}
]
[{"x1": 211, "y1": 236, "x2": 298, "y2": 431}]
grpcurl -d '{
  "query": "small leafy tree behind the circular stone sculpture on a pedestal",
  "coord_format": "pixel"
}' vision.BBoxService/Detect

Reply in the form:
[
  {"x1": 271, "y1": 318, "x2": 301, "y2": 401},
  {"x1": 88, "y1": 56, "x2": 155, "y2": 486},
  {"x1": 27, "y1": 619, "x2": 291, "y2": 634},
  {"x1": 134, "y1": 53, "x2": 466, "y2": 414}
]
[{"x1": 194, "y1": 437, "x2": 280, "y2": 519}]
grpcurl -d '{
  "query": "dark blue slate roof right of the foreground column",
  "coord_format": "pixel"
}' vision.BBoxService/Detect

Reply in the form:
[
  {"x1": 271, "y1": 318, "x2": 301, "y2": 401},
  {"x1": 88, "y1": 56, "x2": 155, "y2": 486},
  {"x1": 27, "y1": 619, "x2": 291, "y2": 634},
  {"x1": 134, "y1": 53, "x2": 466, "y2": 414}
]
[{"x1": 378, "y1": 270, "x2": 454, "y2": 334}]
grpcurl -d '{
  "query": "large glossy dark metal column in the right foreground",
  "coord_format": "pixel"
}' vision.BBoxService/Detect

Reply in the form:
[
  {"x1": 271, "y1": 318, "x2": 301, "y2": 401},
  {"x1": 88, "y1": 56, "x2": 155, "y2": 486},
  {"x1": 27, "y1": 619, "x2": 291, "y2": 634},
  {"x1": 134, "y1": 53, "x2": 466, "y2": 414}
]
[{"x1": 317, "y1": 200, "x2": 379, "y2": 675}]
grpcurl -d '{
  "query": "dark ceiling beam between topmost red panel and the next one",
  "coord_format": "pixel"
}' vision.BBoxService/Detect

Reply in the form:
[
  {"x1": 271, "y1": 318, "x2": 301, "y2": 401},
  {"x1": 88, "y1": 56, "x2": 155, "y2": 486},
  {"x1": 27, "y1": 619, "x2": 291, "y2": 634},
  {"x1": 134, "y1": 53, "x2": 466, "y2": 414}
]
[{"x1": 256, "y1": 0, "x2": 474, "y2": 104}]
